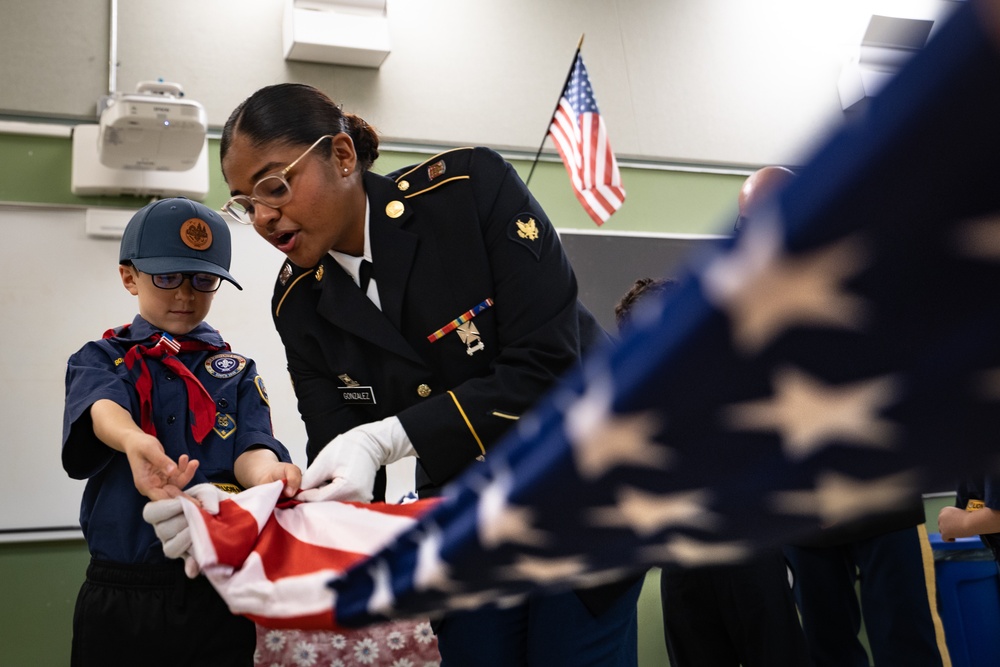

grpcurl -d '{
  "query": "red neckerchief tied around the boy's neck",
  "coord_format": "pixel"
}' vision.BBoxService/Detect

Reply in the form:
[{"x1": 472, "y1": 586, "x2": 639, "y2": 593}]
[{"x1": 104, "y1": 325, "x2": 230, "y2": 444}]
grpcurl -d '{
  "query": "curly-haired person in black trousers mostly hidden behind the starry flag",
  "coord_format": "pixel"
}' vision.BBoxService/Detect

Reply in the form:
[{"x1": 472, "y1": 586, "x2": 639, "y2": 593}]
[{"x1": 615, "y1": 268, "x2": 811, "y2": 667}]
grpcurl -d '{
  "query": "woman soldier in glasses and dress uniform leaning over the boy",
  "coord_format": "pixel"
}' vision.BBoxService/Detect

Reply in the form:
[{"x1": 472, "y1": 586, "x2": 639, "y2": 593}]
[{"x1": 221, "y1": 84, "x2": 639, "y2": 667}]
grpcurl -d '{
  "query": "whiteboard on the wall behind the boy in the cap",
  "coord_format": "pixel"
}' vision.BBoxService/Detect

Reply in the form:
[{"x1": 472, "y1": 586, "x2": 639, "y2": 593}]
[{"x1": 0, "y1": 206, "x2": 306, "y2": 541}]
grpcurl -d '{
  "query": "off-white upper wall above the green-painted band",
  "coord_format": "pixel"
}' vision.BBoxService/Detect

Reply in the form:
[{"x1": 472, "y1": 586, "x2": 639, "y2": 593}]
[{"x1": 0, "y1": 0, "x2": 954, "y2": 166}]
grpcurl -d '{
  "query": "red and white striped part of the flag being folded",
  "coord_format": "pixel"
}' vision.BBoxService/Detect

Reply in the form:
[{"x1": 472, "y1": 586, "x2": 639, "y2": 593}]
[{"x1": 183, "y1": 481, "x2": 437, "y2": 630}]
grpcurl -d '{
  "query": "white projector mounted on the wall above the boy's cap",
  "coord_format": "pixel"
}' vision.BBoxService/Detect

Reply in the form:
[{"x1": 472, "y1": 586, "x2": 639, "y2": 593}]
[{"x1": 97, "y1": 81, "x2": 208, "y2": 171}]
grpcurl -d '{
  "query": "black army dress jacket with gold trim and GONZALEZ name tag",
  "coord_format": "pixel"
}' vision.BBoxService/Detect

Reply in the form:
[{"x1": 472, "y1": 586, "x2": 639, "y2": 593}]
[{"x1": 272, "y1": 148, "x2": 608, "y2": 495}]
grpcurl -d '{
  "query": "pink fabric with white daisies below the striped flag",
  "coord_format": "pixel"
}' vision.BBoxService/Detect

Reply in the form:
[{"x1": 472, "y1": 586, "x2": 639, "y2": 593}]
[{"x1": 254, "y1": 620, "x2": 441, "y2": 667}]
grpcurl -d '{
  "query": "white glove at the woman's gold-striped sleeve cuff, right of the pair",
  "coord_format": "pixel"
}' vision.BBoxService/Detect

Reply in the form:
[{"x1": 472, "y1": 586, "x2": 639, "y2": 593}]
[{"x1": 296, "y1": 417, "x2": 417, "y2": 502}]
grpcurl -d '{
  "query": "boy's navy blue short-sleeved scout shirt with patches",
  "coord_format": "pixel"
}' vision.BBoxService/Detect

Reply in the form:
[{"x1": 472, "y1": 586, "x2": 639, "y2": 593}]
[{"x1": 62, "y1": 316, "x2": 291, "y2": 563}]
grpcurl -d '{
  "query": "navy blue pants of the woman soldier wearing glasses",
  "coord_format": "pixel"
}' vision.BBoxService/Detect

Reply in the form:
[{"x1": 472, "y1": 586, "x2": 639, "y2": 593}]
[{"x1": 435, "y1": 579, "x2": 642, "y2": 667}]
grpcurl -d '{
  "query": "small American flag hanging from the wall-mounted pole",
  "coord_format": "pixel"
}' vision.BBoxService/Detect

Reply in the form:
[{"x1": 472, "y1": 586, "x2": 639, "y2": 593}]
[{"x1": 548, "y1": 48, "x2": 625, "y2": 225}]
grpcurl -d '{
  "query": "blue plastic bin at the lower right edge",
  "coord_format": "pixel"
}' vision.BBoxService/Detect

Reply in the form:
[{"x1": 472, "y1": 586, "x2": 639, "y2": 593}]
[{"x1": 928, "y1": 533, "x2": 1000, "y2": 667}]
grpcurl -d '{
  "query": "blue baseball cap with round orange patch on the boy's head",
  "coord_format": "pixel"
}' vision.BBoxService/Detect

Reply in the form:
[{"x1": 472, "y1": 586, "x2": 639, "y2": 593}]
[{"x1": 118, "y1": 197, "x2": 243, "y2": 289}]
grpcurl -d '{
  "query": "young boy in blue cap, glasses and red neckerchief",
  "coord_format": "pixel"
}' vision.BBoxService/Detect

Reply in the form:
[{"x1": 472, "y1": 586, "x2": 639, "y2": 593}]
[{"x1": 62, "y1": 198, "x2": 301, "y2": 667}]
